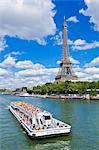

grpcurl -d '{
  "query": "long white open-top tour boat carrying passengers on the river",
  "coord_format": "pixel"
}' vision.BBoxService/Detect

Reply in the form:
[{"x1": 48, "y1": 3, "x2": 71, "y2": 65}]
[{"x1": 9, "y1": 101, "x2": 71, "y2": 139}]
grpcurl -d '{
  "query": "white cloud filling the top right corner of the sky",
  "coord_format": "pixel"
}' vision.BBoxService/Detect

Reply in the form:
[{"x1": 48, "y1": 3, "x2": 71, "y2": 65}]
[{"x1": 79, "y1": 0, "x2": 99, "y2": 31}]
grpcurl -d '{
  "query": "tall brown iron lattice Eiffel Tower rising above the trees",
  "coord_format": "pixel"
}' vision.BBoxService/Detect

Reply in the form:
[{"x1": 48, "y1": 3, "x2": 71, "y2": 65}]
[{"x1": 55, "y1": 18, "x2": 78, "y2": 83}]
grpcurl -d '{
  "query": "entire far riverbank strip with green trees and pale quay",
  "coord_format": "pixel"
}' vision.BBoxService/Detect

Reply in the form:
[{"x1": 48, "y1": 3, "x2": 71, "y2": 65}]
[{"x1": 0, "y1": 81, "x2": 99, "y2": 100}]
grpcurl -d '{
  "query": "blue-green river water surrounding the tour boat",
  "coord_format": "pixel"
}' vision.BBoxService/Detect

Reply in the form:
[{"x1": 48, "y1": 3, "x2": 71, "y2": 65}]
[{"x1": 0, "y1": 95, "x2": 99, "y2": 150}]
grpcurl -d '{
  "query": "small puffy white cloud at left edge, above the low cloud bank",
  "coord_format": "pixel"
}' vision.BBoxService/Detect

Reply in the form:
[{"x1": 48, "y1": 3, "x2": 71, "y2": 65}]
[{"x1": 0, "y1": 56, "x2": 16, "y2": 68}]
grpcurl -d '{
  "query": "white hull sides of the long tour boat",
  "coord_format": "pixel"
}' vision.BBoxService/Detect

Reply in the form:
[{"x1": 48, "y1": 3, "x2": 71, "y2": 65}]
[{"x1": 9, "y1": 106, "x2": 71, "y2": 139}]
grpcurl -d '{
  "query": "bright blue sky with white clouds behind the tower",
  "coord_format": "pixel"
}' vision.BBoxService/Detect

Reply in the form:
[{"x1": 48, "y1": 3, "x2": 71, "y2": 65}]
[{"x1": 0, "y1": 0, "x2": 99, "y2": 89}]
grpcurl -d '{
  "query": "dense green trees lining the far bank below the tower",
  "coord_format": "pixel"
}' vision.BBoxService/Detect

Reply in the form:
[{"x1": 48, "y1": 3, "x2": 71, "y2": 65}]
[{"x1": 32, "y1": 81, "x2": 99, "y2": 95}]
